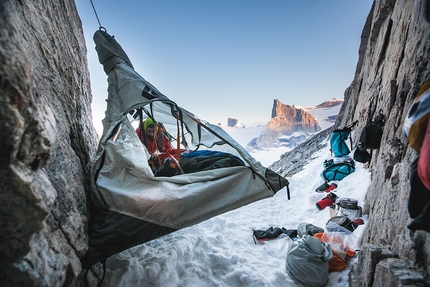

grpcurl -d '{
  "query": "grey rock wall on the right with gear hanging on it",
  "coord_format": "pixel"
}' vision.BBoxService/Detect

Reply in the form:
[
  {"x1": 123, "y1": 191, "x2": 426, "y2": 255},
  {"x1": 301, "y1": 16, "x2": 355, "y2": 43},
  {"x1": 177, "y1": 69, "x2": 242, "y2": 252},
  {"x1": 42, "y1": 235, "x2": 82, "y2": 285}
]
[{"x1": 335, "y1": 0, "x2": 430, "y2": 286}]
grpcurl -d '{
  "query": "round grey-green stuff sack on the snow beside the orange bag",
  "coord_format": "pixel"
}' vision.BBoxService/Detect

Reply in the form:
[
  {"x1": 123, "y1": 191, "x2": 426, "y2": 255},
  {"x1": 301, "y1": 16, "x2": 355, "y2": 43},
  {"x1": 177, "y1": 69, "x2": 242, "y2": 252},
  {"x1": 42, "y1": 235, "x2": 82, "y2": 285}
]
[{"x1": 285, "y1": 235, "x2": 333, "y2": 287}]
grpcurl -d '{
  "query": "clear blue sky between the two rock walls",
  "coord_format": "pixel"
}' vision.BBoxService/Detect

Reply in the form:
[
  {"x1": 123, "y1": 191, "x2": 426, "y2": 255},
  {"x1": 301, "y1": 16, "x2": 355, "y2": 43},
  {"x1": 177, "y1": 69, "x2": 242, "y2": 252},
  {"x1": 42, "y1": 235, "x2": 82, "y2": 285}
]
[{"x1": 76, "y1": 0, "x2": 373, "y2": 137}]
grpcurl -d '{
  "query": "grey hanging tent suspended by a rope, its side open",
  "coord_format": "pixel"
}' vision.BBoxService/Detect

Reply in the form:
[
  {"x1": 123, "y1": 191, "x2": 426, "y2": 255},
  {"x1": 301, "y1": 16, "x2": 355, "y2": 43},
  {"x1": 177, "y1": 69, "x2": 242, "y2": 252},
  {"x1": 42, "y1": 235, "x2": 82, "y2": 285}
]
[{"x1": 82, "y1": 28, "x2": 289, "y2": 269}]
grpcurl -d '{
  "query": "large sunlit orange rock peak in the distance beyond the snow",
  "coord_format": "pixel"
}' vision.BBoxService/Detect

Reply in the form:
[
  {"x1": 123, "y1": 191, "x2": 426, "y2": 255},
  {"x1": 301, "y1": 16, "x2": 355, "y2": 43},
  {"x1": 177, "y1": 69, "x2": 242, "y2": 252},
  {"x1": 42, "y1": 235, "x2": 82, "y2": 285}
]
[{"x1": 267, "y1": 100, "x2": 321, "y2": 134}]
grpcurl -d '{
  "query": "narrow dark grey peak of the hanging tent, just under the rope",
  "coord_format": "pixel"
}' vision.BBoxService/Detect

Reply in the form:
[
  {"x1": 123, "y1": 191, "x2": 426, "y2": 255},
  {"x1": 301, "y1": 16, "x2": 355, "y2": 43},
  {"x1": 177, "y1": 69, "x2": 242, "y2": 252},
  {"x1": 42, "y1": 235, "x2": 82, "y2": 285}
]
[{"x1": 93, "y1": 30, "x2": 134, "y2": 75}]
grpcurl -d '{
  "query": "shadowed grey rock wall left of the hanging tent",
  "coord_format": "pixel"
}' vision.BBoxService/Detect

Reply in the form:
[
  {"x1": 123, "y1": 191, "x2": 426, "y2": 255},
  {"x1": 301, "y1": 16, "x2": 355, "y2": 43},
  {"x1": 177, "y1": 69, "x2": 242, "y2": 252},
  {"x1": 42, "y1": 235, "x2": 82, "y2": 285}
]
[{"x1": 0, "y1": 0, "x2": 97, "y2": 286}]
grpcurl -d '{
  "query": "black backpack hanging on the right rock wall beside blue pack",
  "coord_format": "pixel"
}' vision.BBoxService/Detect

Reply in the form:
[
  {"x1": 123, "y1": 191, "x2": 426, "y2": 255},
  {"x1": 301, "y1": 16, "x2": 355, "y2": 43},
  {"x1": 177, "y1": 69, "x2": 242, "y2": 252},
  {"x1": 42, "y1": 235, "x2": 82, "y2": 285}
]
[{"x1": 354, "y1": 110, "x2": 385, "y2": 163}]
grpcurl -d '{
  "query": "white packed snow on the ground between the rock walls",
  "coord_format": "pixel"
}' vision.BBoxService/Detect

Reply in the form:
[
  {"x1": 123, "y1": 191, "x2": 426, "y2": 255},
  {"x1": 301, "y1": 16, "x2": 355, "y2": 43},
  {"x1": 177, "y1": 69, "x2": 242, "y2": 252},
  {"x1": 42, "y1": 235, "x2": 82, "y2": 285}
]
[{"x1": 102, "y1": 104, "x2": 370, "y2": 287}]
